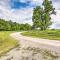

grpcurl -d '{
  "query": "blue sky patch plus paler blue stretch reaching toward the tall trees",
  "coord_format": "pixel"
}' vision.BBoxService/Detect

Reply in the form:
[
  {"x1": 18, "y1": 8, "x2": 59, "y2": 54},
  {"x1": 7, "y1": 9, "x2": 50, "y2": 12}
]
[{"x1": 11, "y1": 0, "x2": 41, "y2": 9}]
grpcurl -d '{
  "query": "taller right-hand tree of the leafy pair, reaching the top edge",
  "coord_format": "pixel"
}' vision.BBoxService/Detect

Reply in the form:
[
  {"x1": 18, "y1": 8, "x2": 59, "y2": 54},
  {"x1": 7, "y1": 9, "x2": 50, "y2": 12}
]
[{"x1": 42, "y1": 0, "x2": 55, "y2": 30}]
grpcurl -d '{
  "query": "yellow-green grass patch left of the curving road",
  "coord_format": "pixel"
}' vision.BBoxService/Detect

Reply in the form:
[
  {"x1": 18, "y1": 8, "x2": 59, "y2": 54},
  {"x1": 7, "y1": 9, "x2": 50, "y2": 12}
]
[{"x1": 0, "y1": 31, "x2": 18, "y2": 56}]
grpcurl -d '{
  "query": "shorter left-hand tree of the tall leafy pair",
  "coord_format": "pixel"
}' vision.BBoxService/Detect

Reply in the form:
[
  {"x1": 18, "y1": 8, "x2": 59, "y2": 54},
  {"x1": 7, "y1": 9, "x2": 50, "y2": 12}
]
[{"x1": 32, "y1": 6, "x2": 43, "y2": 28}]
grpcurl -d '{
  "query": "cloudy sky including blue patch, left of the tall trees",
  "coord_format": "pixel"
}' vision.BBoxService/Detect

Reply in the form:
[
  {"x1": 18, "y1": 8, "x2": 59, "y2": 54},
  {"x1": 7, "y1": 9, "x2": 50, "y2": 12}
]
[{"x1": 0, "y1": 0, "x2": 42, "y2": 24}]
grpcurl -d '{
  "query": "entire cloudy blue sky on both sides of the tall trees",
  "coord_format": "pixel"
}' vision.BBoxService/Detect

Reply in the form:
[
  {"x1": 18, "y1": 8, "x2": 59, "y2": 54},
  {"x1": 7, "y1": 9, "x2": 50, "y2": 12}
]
[{"x1": 0, "y1": 0, "x2": 60, "y2": 28}]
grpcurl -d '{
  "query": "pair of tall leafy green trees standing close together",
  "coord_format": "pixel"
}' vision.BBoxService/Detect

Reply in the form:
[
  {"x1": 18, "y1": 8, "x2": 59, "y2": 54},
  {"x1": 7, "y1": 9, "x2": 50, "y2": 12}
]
[{"x1": 32, "y1": 0, "x2": 55, "y2": 30}]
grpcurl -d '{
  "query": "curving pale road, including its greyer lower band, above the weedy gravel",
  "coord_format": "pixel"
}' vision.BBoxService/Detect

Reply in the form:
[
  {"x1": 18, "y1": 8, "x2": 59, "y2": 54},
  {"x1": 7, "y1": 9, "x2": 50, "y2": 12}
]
[{"x1": 11, "y1": 32, "x2": 60, "y2": 52}]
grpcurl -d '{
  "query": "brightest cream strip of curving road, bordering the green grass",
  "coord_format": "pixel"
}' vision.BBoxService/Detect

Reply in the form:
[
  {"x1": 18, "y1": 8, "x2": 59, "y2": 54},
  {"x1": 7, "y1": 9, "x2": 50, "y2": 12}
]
[{"x1": 11, "y1": 32, "x2": 60, "y2": 47}]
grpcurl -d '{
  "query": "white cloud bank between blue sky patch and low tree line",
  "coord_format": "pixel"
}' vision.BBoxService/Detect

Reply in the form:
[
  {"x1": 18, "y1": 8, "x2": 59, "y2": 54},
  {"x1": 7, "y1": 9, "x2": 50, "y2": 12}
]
[{"x1": 0, "y1": 3, "x2": 33, "y2": 23}]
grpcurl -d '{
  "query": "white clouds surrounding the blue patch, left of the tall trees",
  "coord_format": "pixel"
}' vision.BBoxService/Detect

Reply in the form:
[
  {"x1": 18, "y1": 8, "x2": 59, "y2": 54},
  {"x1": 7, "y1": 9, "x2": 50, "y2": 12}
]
[{"x1": 0, "y1": 0, "x2": 42, "y2": 24}]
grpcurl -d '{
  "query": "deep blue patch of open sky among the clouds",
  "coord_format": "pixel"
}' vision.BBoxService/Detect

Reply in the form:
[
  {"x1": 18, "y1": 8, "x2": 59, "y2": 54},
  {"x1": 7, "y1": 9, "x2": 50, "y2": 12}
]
[{"x1": 11, "y1": 0, "x2": 31, "y2": 9}]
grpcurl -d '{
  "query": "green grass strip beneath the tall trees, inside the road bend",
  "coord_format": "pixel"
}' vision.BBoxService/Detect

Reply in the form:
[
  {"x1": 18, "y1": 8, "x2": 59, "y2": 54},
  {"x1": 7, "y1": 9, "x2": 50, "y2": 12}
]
[{"x1": 22, "y1": 30, "x2": 60, "y2": 40}]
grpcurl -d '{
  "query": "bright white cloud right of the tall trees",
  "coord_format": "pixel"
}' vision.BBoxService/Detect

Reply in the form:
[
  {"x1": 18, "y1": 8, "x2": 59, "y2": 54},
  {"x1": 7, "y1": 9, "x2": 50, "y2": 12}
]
[{"x1": 51, "y1": 10, "x2": 60, "y2": 28}]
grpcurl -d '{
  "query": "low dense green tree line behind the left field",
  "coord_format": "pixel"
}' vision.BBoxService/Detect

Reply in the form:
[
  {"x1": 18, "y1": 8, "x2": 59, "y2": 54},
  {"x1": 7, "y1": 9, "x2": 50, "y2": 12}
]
[{"x1": 0, "y1": 19, "x2": 32, "y2": 31}]
